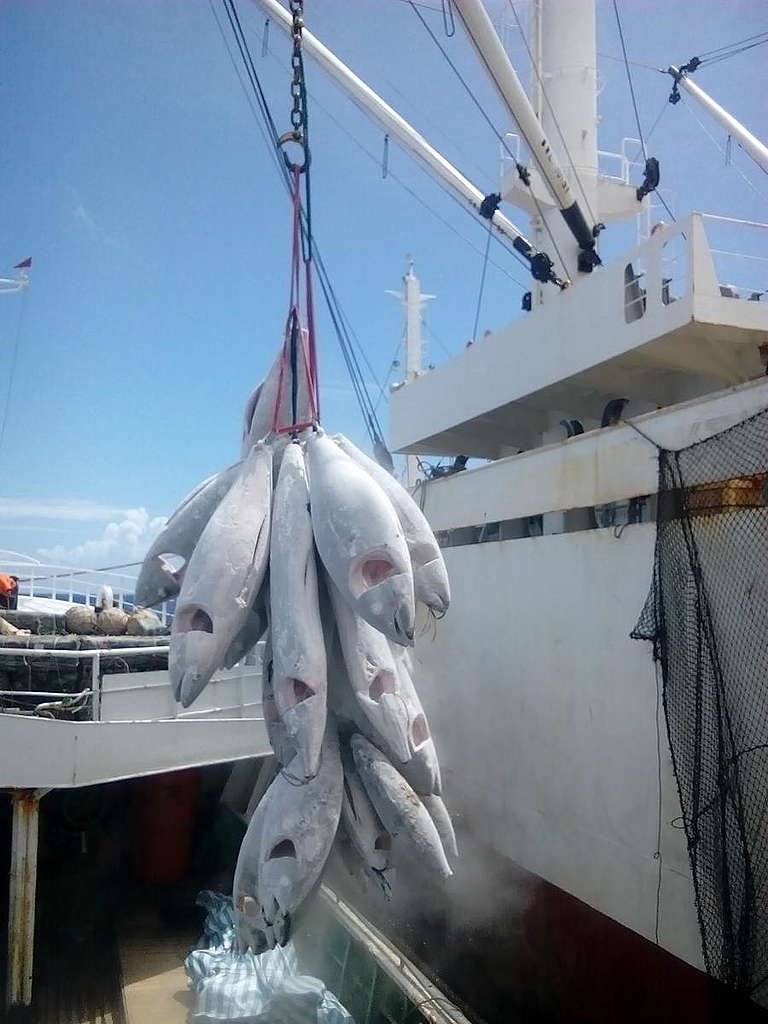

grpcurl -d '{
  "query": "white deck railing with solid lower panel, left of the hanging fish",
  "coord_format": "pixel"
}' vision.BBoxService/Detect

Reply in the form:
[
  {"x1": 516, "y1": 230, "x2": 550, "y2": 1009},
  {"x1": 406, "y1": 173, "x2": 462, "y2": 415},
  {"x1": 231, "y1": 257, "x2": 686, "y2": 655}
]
[{"x1": 0, "y1": 645, "x2": 261, "y2": 722}]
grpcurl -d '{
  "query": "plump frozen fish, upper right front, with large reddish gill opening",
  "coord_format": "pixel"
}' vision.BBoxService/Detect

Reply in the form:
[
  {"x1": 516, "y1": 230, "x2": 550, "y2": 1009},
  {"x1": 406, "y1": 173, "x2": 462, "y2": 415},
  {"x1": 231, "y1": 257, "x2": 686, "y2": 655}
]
[{"x1": 306, "y1": 433, "x2": 415, "y2": 645}]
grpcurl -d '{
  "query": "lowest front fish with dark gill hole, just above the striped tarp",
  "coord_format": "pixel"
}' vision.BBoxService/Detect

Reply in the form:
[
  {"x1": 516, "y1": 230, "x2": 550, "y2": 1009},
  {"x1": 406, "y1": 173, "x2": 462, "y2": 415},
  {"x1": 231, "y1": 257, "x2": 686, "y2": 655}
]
[{"x1": 258, "y1": 717, "x2": 343, "y2": 945}]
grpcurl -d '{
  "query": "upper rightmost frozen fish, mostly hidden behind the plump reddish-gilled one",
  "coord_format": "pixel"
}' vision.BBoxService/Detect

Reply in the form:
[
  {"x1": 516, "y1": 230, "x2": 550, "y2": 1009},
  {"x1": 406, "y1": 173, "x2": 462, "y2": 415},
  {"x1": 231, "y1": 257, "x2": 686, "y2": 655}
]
[{"x1": 334, "y1": 434, "x2": 451, "y2": 614}]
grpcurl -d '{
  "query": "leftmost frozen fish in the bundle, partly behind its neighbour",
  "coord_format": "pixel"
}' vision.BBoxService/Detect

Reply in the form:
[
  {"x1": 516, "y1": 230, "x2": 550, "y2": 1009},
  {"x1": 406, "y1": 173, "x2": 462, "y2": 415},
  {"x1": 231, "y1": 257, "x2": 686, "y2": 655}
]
[{"x1": 134, "y1": 463, "x2": 241, "y2": 608}]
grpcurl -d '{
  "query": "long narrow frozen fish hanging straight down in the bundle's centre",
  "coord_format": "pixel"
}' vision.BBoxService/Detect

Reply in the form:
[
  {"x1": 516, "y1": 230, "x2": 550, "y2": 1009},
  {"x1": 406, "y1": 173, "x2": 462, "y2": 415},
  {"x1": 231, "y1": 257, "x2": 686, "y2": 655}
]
[{"x1": 269, "y1": 443, "x2": 328, "y2": 778}]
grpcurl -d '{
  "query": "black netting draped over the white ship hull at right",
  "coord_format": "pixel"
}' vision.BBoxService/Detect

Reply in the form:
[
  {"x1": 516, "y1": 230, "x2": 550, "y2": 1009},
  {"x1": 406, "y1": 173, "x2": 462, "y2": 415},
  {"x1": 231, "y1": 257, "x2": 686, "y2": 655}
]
[{"x1": 633, "y1": 410, "x2": 768, "y2": 1006}]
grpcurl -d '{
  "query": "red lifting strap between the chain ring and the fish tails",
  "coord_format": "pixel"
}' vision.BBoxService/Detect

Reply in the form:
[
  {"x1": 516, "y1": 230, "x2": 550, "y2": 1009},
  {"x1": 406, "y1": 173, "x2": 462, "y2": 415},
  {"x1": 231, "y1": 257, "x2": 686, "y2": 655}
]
[{"x1": 272, "y1": 167, "x2": 319, "y2": 434}]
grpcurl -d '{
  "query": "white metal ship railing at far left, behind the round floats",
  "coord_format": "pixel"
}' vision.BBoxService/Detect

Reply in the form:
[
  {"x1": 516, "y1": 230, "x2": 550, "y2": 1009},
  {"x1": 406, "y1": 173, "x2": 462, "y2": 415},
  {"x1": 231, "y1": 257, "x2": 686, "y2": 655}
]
[{"x1": 0, "y1": 556, "x2": 174, "y2": 625}]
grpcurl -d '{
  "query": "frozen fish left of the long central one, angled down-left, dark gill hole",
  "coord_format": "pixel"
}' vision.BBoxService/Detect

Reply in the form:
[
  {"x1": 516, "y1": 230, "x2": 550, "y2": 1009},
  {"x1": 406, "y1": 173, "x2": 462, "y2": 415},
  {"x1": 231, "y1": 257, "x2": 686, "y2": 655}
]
[{"x1": 168, "y1": 444, "x2": 272, "y2": 708}]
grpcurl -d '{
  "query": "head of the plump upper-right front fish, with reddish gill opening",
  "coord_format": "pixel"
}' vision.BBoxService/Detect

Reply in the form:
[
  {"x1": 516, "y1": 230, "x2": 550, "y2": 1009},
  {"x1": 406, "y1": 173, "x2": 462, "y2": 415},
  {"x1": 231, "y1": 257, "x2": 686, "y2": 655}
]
[{"x1": 349, "y1": 550, "x2": 416, "y2": 647}]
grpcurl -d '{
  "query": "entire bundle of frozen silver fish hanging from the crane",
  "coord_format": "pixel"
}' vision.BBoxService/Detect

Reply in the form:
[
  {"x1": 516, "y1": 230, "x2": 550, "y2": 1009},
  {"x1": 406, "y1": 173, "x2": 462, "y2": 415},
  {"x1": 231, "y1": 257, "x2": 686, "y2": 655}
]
[{"x1": 136, "y1": 348, "x2": 457, "y2": 950}]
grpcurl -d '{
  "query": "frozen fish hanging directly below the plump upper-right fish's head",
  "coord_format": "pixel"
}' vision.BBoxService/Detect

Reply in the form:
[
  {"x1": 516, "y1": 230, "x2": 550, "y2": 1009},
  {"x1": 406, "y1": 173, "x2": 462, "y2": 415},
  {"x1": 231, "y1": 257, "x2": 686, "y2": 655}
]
[{"x1": 327, "y1": 579, "x2": 411, "y2": 762}]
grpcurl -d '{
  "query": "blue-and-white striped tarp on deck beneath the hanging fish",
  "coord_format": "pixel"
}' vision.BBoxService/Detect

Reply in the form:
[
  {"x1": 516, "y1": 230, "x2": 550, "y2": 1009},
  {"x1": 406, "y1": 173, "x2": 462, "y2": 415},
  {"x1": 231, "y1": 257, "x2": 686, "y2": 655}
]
[{"x1": 184, "y1": 890, "x2": 354, "y2": 1024}]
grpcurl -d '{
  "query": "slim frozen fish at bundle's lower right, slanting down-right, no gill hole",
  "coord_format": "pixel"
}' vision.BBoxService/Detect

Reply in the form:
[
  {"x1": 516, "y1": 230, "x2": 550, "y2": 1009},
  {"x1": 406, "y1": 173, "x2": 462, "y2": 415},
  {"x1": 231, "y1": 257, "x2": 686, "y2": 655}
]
[{"x1": 349, "y1": 733, "x2": 453, "y2": 879}]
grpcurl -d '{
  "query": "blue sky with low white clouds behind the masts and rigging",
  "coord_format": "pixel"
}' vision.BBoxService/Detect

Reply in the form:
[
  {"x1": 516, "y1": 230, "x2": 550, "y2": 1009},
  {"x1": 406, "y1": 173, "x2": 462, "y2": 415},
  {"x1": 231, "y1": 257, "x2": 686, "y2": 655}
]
[{"x1": 0, "y1": 0, "x2": 768, "y2": 568}]
